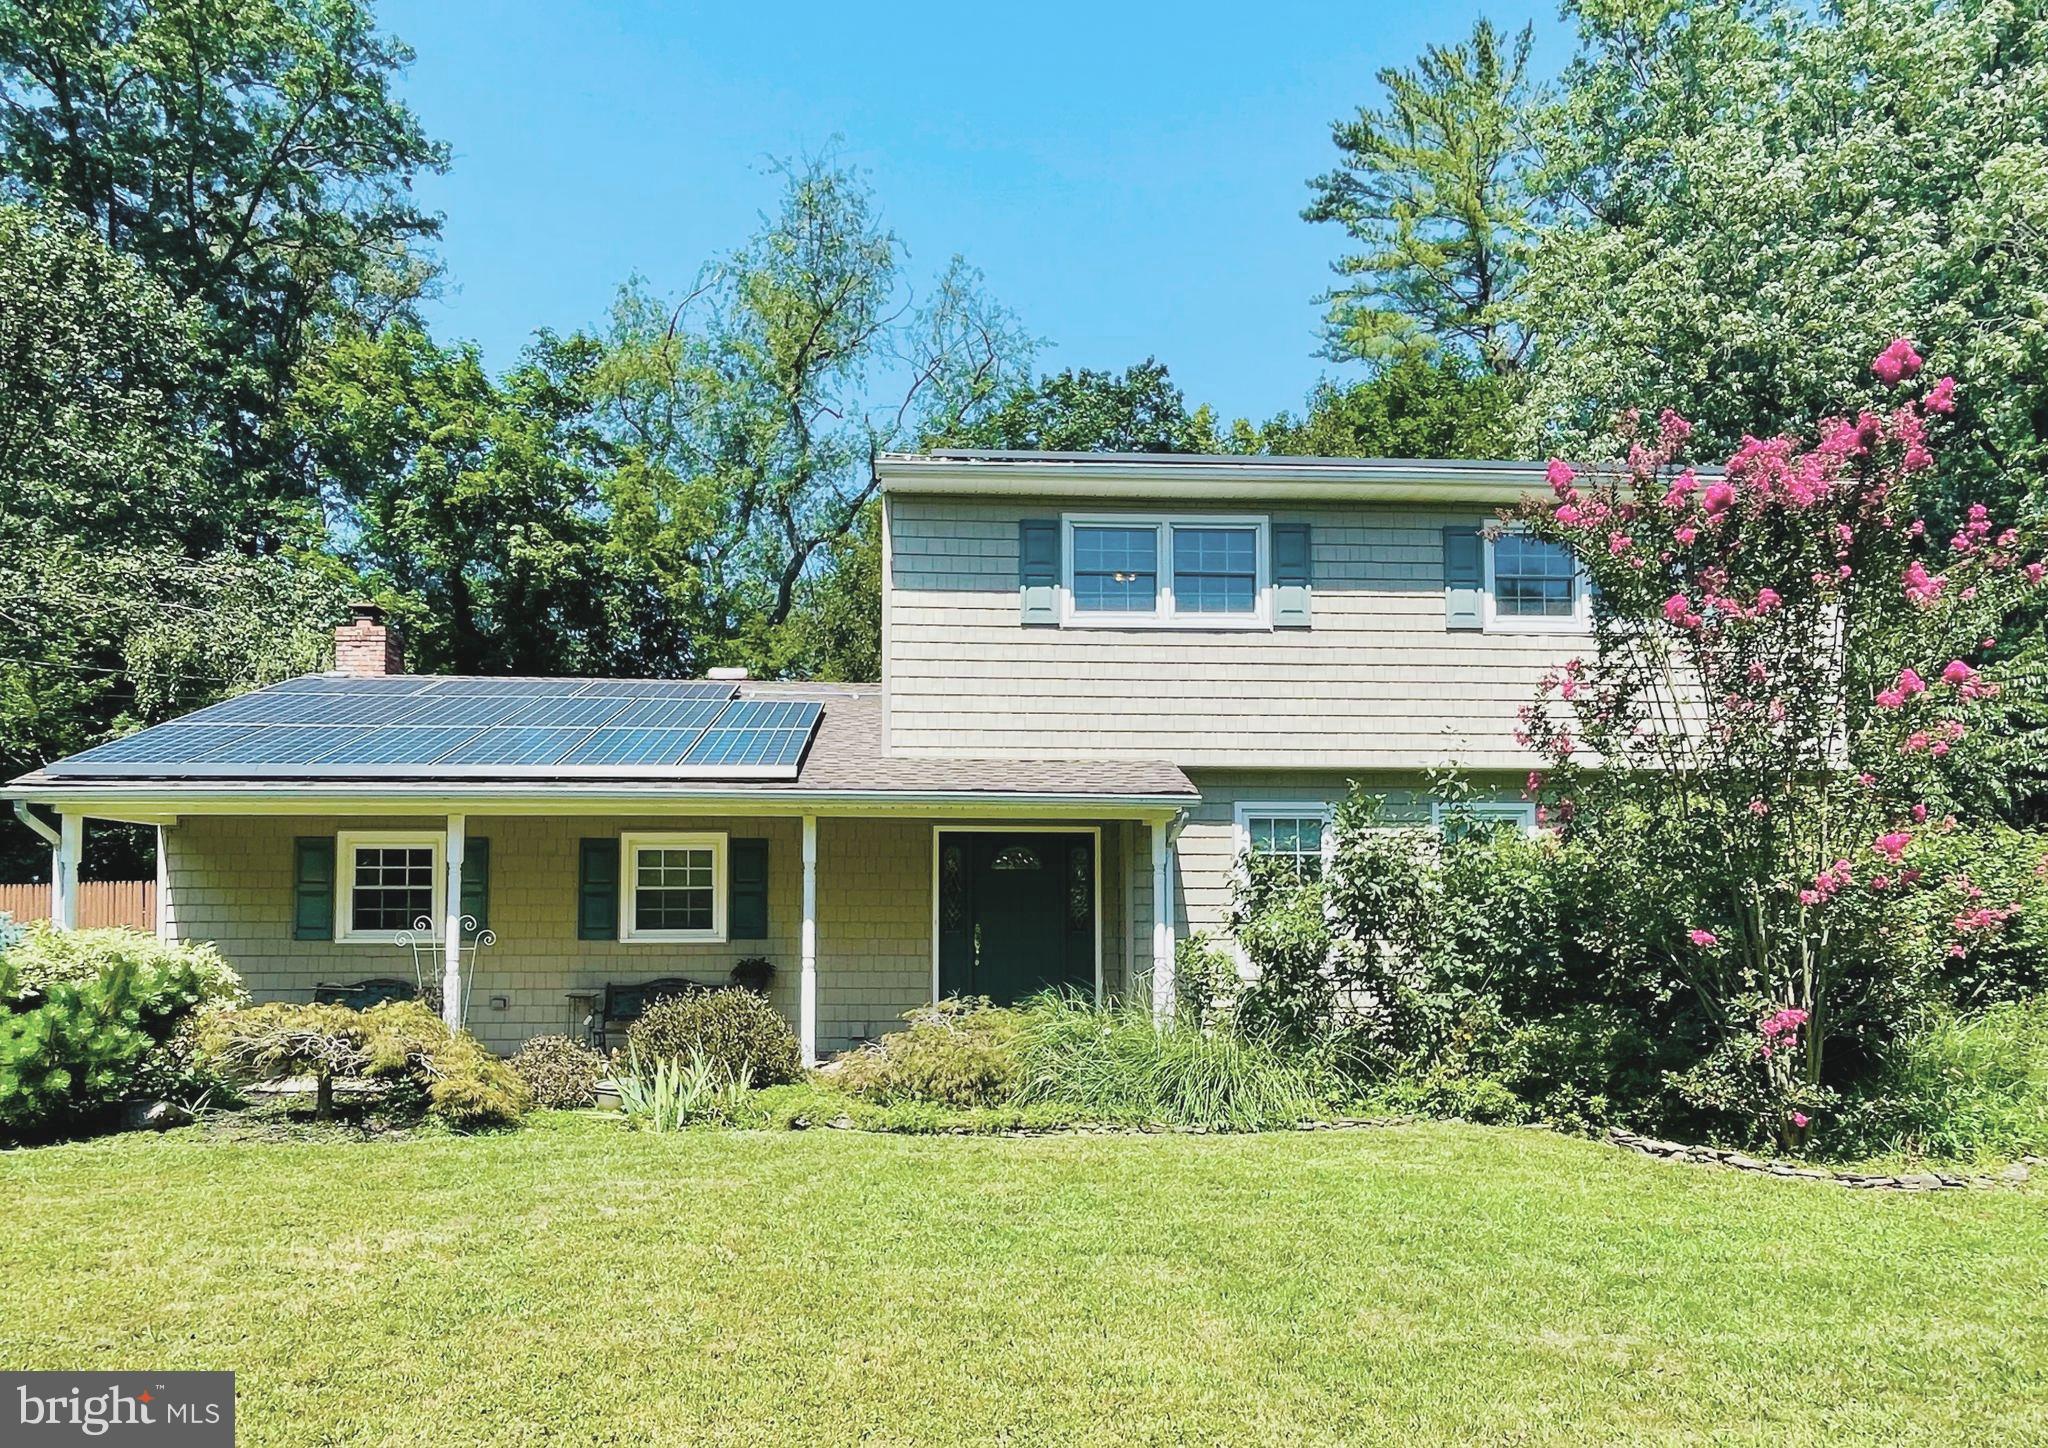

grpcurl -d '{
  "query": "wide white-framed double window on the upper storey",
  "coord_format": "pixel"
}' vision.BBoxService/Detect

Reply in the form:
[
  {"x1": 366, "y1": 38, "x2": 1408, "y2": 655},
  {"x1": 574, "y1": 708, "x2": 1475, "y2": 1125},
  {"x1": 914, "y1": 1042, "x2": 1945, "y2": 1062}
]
[{"x1": 1065, "y1": 516, "x2": 1272, "y2": 629}]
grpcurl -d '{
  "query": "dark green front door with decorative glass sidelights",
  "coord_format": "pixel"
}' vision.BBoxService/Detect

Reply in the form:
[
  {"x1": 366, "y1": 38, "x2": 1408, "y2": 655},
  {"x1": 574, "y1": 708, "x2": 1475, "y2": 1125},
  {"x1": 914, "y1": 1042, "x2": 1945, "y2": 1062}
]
[{"x1": 938, "y1": 829, "x2": 1096, "y2": 1006}]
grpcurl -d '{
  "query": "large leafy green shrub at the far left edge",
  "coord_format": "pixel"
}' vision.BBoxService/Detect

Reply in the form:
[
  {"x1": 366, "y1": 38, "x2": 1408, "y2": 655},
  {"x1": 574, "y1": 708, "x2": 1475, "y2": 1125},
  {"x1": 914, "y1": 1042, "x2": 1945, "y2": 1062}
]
[{"x1": 0, "y1": 928, "x2": 242, "y2": 1137}]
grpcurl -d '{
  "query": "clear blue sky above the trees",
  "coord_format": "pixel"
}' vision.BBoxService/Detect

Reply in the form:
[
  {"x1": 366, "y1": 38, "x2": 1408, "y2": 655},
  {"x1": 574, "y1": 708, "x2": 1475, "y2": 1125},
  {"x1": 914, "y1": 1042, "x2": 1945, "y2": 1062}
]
[{"x1": 379, "y1": 0, "x2": 1569, "y2": 418}]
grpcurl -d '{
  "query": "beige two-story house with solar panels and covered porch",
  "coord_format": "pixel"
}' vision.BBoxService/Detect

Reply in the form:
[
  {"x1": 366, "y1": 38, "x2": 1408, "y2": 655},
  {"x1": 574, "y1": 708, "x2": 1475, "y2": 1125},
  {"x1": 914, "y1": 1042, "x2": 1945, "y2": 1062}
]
[{"x1": 6, "y1": 453, "x2": 1587, "y2": 1059}]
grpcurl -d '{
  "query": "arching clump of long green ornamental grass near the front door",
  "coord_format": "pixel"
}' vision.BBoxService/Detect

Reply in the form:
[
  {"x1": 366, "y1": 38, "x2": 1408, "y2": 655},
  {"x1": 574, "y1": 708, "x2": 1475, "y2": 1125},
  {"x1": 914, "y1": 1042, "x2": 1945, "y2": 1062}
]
[{"x1": 1018, "y1": 997, "x2": 1341, "y2": 1131}]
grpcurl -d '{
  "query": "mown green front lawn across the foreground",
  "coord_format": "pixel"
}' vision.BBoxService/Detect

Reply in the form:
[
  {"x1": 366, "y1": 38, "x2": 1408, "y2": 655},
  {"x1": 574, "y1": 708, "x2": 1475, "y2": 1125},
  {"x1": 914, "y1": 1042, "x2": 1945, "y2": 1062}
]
[{"x1": 0, "y1": 1116, "x2": 2048, "y2": 1444}]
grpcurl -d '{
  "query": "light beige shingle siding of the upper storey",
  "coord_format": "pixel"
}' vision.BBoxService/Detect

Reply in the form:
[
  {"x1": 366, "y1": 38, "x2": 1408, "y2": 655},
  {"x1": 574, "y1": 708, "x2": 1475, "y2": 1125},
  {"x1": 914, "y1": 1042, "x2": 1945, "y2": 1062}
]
[{"x1": 885, "y1": 496, "x2": 1585, "y2": 770}]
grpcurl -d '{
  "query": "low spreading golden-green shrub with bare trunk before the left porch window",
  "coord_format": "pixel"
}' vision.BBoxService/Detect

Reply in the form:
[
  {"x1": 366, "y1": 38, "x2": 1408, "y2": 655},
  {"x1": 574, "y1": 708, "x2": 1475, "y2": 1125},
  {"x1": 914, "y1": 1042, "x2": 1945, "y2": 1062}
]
[{"x1": 203, "y1": 1002, "x2": 532, "y2": 1128}]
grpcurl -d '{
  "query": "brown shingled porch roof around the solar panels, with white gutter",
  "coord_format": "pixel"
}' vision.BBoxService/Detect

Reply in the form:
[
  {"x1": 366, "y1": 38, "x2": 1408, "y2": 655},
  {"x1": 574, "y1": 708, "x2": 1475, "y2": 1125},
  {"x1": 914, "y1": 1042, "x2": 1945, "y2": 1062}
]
[{"x1": 0, "y1": 682, "x2": 1200, "y2": 813}]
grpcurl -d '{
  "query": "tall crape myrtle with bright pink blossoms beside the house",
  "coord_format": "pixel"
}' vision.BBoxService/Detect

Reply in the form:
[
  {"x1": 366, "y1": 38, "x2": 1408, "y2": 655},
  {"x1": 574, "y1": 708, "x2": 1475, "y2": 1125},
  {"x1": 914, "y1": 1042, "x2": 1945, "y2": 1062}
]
[{"x1": 1509, "y1": 340, "x2": 2042, "y2": 1147}]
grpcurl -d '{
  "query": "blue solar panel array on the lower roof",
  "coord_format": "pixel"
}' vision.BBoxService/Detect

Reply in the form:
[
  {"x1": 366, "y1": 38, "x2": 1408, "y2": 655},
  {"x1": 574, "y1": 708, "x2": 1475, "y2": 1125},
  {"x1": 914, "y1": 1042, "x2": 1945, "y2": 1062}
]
[{"x1": 47, "y1": 674, "x2": 823, "y2": 780}]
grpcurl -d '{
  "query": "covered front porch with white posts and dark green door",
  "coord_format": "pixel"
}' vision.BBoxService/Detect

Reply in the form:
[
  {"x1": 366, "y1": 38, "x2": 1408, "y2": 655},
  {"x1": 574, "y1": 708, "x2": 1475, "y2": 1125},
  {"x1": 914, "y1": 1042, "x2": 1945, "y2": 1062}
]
[{"x1": 53, "y1": 791, "x2": 1178, "y2": 1063}]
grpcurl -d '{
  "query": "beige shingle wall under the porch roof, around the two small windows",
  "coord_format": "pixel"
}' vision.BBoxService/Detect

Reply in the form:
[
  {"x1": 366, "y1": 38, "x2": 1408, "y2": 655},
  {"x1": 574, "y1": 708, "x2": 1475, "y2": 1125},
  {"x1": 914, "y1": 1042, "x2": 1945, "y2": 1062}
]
[{"x1": 166, "y1": 815, "x2": 1149, "y2": 1053}]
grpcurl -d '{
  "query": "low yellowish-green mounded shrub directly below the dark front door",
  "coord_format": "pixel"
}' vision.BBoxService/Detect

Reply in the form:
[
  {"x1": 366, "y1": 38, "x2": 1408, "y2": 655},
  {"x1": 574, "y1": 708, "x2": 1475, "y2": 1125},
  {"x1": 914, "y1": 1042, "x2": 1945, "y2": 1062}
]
[{"x1": 831, "y1": 999, "x2": 1024, "y2": 1108}]
